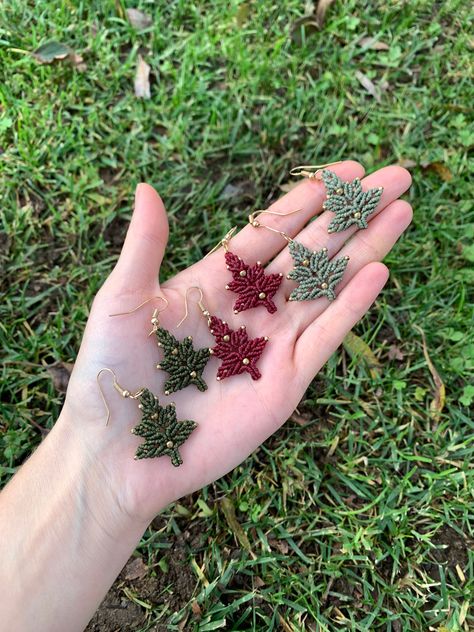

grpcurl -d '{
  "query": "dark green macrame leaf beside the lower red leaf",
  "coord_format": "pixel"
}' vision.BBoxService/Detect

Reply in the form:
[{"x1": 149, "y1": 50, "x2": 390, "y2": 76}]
[{"x1": 156, "y1": 327, "x2": 210, "y2": 395}]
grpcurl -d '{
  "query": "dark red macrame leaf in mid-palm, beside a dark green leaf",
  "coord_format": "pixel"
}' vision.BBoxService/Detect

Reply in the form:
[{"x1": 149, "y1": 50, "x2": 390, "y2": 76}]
[{"x1": 209, "y1": 316, "x2": 268, "y2": 380}]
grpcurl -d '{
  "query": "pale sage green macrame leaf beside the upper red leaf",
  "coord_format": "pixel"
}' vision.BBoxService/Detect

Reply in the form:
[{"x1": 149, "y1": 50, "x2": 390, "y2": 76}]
[{"x1": 287, "y1": 241, "x2": 349, "y2": 301}]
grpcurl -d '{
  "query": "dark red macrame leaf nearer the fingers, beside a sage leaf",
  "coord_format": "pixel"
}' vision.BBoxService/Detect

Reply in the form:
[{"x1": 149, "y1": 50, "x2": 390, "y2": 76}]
[{"x1": 225, "y1": 251, "x2": 283, "y2": 314}]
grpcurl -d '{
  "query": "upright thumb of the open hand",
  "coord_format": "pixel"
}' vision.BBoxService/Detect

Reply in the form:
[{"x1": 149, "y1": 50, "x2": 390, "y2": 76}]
[{"x1": 111, "y1": 183, "x2": 169, "y2": 289}]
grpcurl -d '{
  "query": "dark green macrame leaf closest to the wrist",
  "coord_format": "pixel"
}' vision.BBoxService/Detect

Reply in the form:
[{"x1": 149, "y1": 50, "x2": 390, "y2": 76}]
[{"x1": 132, "y1": 389, "x2": 197, "y2": 467}]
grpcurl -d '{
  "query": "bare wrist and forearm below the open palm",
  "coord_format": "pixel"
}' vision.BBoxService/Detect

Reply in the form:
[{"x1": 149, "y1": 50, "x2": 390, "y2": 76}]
[{"x1": 0, "y1": 409, "x2": 147, "y2": 632}]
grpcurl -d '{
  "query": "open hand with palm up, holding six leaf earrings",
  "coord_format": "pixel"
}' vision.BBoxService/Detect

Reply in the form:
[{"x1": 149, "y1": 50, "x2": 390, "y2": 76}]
[{"x1": 61, "y1": 161, "x2": 412, "y2": 522}]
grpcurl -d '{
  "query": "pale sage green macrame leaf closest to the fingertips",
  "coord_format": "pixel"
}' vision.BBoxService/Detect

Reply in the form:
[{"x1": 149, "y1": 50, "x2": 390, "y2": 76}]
[{"x1": 322, "y1": 169, "x2": 383, "y2": 233}]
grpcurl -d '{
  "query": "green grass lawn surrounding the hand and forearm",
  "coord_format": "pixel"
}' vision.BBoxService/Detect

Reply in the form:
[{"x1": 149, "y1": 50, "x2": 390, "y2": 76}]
[{"x1": 0, "y1": 0, "x2": 474, "y2": 632}]
